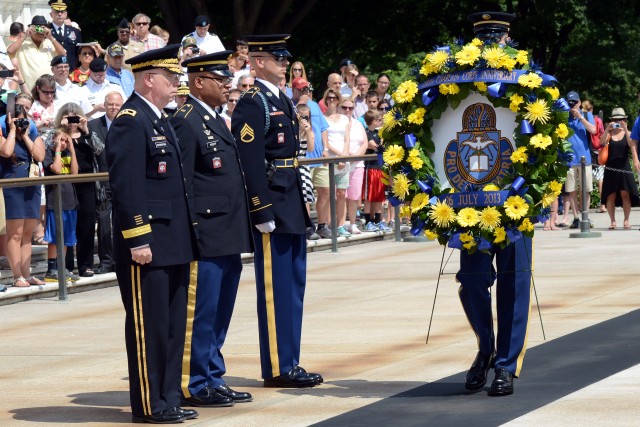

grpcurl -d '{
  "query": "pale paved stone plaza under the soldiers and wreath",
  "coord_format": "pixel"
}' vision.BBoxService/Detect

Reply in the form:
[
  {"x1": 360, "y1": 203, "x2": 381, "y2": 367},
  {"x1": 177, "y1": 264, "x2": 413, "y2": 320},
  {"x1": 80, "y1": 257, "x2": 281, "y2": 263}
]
[{"x1": 0, "y1": 210, "x2": 640, "y2": 427}]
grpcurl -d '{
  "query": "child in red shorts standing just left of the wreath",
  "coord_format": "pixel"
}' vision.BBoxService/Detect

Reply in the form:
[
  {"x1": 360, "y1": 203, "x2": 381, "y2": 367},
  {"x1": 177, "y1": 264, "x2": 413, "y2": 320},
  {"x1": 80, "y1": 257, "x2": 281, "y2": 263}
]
[{"x1": 363, "y1": 110, "x2": 391, "y2": 231}]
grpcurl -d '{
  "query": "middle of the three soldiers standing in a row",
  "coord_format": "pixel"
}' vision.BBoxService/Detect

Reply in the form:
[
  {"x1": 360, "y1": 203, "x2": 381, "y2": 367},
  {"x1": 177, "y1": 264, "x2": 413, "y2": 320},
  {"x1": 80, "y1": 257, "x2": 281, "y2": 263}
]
[{"x1": 171, "y1": 51, "x2": 253, "y2": 407}]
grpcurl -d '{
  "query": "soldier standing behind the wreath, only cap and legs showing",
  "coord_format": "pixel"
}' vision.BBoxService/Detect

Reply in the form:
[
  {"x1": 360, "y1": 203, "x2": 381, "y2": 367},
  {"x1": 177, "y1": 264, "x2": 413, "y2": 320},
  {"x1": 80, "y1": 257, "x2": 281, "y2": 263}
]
[{"x1": 456, "y1": 12, "x2": 533, "y2": 396}]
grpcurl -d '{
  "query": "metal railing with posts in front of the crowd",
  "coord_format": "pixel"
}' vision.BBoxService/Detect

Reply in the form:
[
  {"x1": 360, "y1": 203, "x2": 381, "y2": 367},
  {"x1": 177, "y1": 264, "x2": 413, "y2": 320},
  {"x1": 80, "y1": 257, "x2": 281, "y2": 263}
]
[{"x1": 0, "y1": 154, "x2": 402, "y2": 301}]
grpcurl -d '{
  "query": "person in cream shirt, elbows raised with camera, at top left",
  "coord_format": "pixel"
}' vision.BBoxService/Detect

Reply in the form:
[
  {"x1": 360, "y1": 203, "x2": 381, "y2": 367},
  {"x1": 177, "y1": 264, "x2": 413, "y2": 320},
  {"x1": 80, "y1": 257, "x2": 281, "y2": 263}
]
[{"x1": 7, "y1": 15, "x2": 66, "y2": 91}]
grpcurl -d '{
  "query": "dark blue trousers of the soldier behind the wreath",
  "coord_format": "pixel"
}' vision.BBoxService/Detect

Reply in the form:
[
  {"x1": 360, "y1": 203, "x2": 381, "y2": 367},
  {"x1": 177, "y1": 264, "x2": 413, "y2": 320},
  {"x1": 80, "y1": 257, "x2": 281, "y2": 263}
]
[{"x1": 456, "y1": 237, "x2": 533, "y2": 377}]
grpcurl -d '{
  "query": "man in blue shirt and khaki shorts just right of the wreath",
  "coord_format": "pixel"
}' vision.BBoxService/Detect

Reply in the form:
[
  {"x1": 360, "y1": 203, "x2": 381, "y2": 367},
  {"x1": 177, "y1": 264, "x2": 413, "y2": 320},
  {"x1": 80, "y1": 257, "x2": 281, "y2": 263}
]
[{"x1": 564, "y1": 91, "x2": 596, "y2": 228}]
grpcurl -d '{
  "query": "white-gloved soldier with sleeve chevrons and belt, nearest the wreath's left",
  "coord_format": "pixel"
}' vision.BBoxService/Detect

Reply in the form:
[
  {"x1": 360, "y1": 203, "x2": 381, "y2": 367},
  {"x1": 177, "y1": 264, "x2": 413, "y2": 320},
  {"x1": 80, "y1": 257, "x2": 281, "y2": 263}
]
[{"x1": 231, "y1": 34, "x2": 323, "y2": 387}]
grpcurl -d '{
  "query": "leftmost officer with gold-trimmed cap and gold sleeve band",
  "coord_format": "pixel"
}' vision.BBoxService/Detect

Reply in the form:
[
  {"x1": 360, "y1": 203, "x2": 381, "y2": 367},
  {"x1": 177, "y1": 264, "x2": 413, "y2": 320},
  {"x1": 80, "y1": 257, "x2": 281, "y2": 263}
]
[{"x1": 106, "y1": 45, "x2": 198, "y2": 423}]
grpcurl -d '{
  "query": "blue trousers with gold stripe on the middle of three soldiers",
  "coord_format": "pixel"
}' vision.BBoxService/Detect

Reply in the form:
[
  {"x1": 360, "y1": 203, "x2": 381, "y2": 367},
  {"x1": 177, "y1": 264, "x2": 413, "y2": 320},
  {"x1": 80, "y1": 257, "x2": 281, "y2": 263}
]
[{"x1": 182, "y1": 254, "x2": 242, "y2": 397}]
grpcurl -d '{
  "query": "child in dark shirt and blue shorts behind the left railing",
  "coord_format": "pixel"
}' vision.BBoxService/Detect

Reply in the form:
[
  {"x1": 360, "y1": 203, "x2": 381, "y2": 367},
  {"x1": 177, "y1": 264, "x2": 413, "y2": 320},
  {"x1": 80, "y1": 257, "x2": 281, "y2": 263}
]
[{"x1": 43, "y1": 126, "x2": 79, "y2": 282}]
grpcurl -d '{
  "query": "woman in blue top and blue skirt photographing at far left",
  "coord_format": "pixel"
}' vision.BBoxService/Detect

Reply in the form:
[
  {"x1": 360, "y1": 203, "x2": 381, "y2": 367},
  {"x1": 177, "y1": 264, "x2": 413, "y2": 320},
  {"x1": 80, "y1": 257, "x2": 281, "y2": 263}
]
[{"x1": 0, "y1": 105, "x2": 45, "y2": 287}]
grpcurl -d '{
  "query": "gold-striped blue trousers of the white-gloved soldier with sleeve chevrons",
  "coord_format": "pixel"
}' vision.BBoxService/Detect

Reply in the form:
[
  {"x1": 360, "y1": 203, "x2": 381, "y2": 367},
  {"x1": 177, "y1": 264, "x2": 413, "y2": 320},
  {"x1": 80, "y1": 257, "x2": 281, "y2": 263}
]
[{"x1": 253, "y1": 230, "x2": 307, "y2": 379}]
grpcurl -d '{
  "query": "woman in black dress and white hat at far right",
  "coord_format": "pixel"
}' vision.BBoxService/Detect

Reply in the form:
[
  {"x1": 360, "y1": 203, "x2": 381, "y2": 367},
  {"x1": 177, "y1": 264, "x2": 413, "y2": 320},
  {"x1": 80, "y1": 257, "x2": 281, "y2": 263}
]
[{"x1": 600, "y1": 107, "x2": 640, "y2": 230}]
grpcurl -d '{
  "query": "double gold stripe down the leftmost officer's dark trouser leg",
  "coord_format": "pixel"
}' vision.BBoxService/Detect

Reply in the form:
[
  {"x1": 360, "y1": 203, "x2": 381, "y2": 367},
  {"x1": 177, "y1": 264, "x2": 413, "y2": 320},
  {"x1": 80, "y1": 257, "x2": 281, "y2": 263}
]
[{"x1": 131, "y1": 265, "x2": 151, "y2": 415}]
